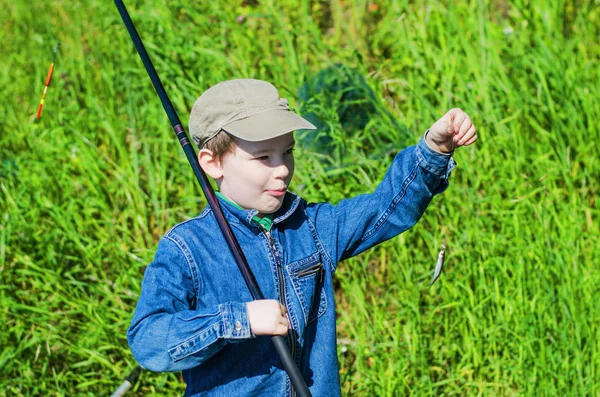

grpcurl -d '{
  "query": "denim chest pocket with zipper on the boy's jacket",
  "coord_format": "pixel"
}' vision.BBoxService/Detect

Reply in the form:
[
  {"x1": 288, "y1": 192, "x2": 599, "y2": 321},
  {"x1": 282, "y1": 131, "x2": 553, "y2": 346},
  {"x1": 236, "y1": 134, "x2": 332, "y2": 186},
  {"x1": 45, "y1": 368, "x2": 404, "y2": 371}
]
[{"x1": 287, "y1": 253, "x2": 327, "y2": 324}]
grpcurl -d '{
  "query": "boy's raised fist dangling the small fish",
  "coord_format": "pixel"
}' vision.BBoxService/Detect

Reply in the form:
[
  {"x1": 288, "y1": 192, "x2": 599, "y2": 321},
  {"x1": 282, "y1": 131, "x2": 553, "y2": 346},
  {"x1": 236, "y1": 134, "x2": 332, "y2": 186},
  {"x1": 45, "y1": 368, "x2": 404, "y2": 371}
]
[{"x1": 425, "y1": 108, "x2": 477, "y2": 153}]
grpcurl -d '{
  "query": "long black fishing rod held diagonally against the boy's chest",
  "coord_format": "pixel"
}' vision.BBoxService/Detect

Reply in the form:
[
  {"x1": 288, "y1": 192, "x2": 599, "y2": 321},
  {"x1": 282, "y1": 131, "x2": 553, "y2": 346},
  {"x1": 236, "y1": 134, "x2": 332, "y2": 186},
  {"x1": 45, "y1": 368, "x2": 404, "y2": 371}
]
[{"x1": 115, "y1": 0, "x2": 311, "y2": 397}]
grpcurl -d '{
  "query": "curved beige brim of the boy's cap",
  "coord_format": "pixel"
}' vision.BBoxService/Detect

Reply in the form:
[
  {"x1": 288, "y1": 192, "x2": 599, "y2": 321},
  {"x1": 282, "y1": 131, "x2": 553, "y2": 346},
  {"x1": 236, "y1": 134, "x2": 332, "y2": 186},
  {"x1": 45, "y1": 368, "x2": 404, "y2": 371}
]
[{"x1": 222, "y1": 109, "x2": 317, "y2": 142}]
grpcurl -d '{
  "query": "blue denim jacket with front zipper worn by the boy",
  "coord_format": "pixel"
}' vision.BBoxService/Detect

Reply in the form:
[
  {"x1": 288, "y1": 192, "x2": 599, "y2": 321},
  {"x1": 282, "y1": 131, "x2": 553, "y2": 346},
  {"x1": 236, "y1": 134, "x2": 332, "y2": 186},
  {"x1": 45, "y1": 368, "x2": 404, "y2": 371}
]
[{"x1": 127, "y1": 139, "x2": 455, "y2": 397}]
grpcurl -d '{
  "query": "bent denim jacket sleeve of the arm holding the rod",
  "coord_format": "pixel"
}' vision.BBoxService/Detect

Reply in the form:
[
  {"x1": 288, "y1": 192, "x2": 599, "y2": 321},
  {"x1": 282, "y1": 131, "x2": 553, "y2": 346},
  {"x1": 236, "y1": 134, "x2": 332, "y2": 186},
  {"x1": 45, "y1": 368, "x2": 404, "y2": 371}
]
[{"x1": 127, "y1": 234, "x2": 252, "y2": 372}]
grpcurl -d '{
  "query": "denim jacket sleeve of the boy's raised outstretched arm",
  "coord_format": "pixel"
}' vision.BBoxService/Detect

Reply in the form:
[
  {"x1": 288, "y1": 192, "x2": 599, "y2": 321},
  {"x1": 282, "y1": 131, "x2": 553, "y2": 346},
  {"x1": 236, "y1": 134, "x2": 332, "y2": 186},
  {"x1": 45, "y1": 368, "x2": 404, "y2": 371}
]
[{"x1": 306, "y1": 138, "x2": 455, "y2": 271}]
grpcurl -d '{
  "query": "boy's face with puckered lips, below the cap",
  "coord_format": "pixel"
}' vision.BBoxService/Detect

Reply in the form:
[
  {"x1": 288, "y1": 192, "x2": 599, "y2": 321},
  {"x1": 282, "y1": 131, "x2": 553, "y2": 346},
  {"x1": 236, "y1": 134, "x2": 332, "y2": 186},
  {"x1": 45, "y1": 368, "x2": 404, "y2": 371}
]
[{"x1": 219, "y1": 132, "x2": 295, "y2": 216}]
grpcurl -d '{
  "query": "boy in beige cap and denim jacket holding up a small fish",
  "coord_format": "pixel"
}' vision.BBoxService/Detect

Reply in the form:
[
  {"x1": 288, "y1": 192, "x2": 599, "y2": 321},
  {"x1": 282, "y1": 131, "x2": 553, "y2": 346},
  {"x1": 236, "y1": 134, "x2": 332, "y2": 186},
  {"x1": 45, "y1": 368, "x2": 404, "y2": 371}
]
[{"x1": 127, "y1": 79, "x2": 477, "y2": 396}]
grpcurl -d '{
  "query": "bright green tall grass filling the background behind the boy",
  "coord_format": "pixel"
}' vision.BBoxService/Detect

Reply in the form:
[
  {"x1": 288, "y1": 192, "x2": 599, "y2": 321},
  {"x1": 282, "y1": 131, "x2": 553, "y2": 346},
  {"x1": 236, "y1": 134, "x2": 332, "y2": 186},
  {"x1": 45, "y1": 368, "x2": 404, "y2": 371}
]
[{"x1": 0, "y1": 0, "x2": 600, "y2": 396}]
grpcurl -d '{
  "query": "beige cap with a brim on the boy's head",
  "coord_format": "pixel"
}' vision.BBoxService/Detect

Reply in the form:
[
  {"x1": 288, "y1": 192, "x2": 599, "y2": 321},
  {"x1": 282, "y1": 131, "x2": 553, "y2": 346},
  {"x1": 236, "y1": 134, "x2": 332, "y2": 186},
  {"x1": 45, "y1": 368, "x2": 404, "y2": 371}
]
[{"x1": 189, "y1": 79, "x2": 316, "y2": 148}]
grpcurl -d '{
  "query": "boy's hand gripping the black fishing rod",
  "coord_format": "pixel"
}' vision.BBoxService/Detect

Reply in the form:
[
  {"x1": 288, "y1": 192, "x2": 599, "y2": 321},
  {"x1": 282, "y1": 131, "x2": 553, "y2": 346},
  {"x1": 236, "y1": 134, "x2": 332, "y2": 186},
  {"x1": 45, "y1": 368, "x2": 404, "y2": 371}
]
[{"x1": 246, "y1": 299, "x2": 290, "y2": 336}]
